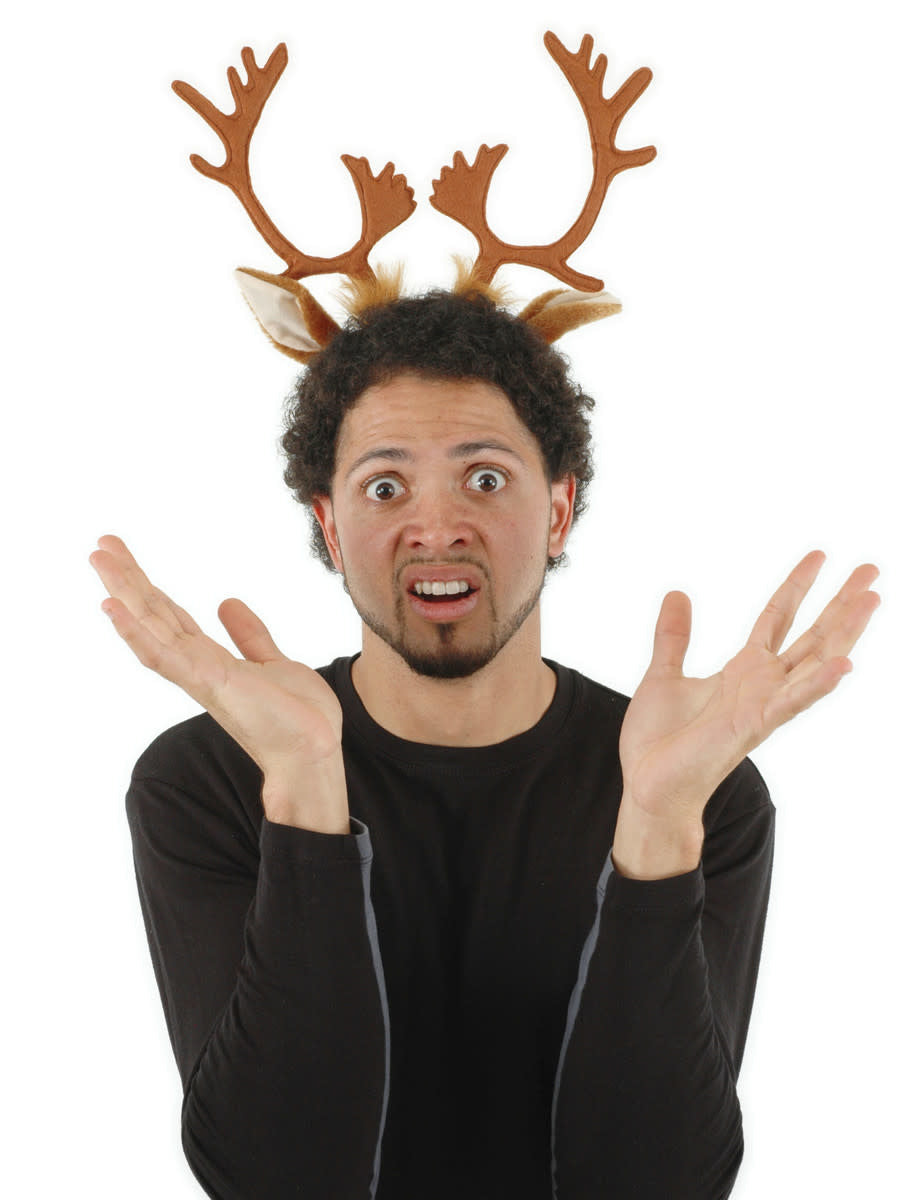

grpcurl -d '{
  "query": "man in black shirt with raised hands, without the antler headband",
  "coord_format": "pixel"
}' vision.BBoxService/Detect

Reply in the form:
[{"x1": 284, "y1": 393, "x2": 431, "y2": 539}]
[{"x1": 90, "y1": 285, "x2": 879, "y2": 1200}]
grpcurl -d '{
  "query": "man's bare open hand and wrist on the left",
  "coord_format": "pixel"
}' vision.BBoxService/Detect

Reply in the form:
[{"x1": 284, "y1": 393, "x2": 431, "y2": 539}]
[{"x1": 89, "y1": 534, "x2": 349, "y2": 832}]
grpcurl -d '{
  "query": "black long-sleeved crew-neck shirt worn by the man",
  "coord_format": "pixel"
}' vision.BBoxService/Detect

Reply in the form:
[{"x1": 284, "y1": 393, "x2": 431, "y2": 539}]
[{"x1": 126, "y1": 654, "x2": 774, "y2": 1200}]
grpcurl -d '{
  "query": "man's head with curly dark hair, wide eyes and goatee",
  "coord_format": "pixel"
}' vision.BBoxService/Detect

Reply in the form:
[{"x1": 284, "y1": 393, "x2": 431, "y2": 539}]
[{"x1": 281, "y1": 292, "x2": 593, "y2": 678}]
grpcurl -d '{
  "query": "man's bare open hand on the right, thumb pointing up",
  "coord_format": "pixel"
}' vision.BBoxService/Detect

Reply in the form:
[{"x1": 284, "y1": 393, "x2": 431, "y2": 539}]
[{"x1": 616, "y1": 550, "x2": 880, "y2": 835}]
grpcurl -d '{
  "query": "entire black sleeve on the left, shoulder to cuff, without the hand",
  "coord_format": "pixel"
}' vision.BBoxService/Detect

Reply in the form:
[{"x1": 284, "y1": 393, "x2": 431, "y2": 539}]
[{"x1": 126, "y1": 716, "x2": 389, "y2": 1200}]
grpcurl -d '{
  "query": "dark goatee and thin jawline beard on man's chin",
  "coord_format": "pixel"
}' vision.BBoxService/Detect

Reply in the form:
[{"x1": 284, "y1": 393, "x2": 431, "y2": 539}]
[{"x1": 342, "y1": 564, "x2": 547, "y2": 679}]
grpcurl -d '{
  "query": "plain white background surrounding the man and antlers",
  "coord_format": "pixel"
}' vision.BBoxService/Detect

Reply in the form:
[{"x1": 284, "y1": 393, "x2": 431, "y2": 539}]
[{"x1": 2, "y1": 0, "x2": 922, "y2": 1200}]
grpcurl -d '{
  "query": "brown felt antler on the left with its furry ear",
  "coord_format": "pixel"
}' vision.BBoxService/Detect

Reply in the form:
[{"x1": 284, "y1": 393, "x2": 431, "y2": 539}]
[{"x1": 173, "y1": 42, "x2": 417, "y2": 361}]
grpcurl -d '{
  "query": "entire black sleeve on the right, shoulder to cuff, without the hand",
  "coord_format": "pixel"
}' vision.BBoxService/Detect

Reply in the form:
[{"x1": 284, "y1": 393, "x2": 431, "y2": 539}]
[{"x1": 552, "y1": 758, "x2": 774, "y2": 1200}]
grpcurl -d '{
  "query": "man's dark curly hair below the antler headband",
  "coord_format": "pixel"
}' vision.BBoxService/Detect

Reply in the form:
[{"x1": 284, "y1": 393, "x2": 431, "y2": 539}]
[{"x1": 279, "y1": 289, "x2": 595, "y2": 571}]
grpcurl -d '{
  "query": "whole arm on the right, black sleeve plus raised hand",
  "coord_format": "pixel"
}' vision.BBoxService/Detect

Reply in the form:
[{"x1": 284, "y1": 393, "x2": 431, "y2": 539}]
[{"x1": 552, "y1": 551, "x2": 880, "y2": 1200}]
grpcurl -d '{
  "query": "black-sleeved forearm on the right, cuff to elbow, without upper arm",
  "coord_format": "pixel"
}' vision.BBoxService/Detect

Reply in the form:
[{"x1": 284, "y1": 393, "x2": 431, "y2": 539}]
[{"x1": 552, "y1": 849, "x2": 743, "y2": 1200}]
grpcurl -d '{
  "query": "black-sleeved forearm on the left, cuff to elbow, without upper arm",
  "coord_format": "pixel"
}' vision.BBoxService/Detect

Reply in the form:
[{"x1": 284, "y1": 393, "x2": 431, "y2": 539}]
[{"x1": 182, "y1": 822, "x2": 389, "y2": 1200}]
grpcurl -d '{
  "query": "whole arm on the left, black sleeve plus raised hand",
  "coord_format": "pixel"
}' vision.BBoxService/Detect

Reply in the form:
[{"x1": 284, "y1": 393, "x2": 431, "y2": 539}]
[{"x1": 90, "y1": 534, "x2": 390, "y2": 1200}]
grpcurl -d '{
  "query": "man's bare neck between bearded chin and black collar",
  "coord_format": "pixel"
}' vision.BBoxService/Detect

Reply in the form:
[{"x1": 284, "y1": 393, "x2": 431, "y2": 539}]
[{"x1": 352, "y1": 613, "x2": 557, "y2": 746}]
